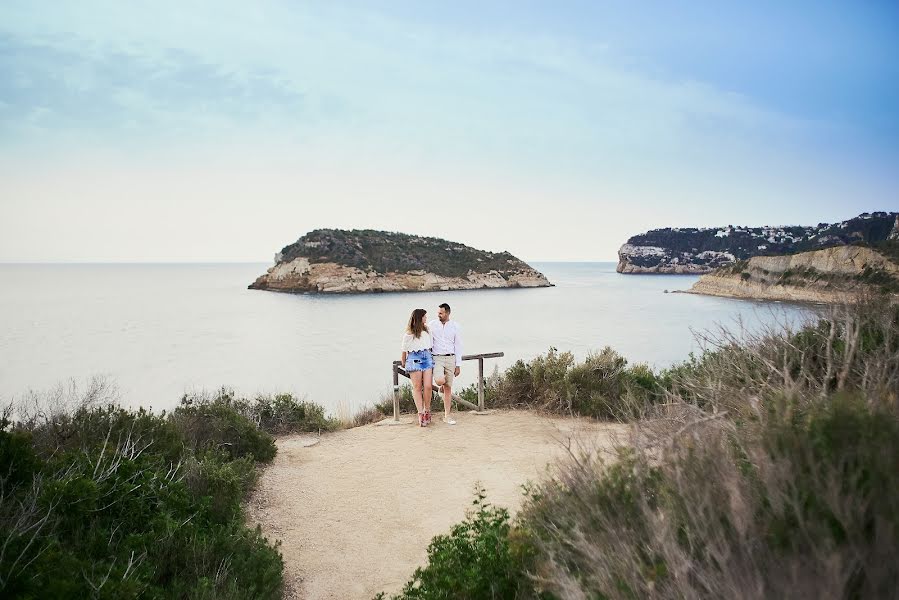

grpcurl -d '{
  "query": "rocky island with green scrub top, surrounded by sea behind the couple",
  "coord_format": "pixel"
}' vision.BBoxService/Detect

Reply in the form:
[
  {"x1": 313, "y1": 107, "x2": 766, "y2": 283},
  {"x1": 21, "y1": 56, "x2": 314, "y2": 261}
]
[{"x1": 249, "y1": 229, "x2": 552, "y2": 294}]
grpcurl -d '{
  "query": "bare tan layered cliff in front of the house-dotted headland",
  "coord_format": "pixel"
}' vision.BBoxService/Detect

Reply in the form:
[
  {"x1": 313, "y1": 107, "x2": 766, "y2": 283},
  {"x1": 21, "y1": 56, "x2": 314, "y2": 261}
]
[{"x1": 688, "y1": 242, "x2": 899, "y2": 303}]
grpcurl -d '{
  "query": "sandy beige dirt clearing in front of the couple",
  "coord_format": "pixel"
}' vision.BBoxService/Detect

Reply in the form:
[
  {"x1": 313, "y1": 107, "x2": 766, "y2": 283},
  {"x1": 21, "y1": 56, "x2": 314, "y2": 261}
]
[{"x1": 249, "y1": 411, "x2": 622, "y2": 599}]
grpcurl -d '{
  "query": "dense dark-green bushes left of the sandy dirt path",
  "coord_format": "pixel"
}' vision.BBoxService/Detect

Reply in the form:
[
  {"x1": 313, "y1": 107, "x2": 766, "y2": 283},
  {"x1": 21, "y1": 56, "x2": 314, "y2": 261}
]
[{"x1": 0, "y1": 396, "x2": 283, "y2": 600}]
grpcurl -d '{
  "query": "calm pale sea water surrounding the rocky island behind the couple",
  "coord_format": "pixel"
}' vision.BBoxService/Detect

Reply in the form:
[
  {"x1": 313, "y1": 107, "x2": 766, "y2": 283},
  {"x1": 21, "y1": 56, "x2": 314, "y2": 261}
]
[{"x1": 0, "y1": 263, "x2": 807, "y2": 412}]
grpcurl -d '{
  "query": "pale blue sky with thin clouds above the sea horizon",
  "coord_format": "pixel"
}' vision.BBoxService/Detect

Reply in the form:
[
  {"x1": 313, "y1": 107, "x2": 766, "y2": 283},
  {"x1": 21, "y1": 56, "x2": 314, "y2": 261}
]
[{"x1": 0, "y1": 0, "x2": 899, "y2": 262}]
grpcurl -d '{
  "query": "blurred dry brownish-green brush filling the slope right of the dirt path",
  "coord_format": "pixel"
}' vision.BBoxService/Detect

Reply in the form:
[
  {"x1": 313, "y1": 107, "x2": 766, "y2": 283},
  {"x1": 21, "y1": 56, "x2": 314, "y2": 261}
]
[{"x1": 518, "y1": 301, "x2": 899, "y2": 599}]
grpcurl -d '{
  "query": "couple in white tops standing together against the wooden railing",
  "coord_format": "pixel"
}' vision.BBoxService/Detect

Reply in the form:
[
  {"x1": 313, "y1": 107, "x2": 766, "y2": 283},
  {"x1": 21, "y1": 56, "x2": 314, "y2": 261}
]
[{"x1": 400, "y1": 302, "x2": 462, "y2": 427}]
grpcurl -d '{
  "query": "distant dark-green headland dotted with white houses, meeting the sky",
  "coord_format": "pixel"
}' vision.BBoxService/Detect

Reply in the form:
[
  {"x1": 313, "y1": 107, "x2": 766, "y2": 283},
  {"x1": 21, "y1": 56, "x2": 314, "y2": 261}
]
[{"x1": 617, "y1": 212, "x2": 899, "y2": 274}]
